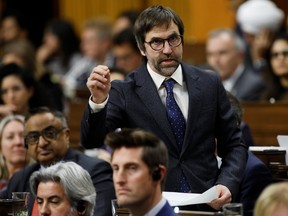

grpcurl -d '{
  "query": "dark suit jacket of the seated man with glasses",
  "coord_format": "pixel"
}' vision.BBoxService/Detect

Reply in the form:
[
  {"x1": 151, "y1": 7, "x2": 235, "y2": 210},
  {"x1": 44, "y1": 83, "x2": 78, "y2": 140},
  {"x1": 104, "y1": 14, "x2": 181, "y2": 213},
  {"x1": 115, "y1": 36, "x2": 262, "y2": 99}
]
[{"x1": 0, "y1": 149, "x2": 116, "y2": 216}]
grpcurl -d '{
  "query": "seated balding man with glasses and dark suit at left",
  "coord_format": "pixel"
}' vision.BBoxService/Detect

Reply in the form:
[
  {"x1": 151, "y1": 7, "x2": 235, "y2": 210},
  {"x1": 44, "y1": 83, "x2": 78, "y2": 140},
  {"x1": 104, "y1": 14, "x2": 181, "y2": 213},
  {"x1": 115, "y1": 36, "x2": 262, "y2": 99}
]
[{"x1": 0, "y1": 107, "x2": 115, "y2": 216}]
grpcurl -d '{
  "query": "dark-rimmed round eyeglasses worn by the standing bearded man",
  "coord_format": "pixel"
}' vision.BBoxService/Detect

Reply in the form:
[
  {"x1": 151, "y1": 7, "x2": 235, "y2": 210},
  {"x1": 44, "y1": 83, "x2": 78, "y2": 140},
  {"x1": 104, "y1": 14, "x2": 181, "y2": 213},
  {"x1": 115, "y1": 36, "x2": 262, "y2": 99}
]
[{"x1": 145, "y1": 34, "x2": 182, "y2": 51}]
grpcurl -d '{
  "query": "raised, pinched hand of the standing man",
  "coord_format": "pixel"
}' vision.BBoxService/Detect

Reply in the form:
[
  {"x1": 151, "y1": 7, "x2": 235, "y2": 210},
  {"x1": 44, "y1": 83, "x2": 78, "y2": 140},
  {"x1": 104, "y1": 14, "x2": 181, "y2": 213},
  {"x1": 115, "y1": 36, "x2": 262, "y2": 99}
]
[{"x1": 86, "y1": 65, "x2": 111, "y2": 104}]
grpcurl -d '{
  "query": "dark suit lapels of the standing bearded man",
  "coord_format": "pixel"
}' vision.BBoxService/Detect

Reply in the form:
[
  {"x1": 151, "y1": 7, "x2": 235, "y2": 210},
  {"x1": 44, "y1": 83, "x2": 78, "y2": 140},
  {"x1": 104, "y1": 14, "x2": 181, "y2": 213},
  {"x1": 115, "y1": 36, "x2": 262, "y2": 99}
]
[{"x1": 135, "y1": 64, "x2": 203, "y2": 153}]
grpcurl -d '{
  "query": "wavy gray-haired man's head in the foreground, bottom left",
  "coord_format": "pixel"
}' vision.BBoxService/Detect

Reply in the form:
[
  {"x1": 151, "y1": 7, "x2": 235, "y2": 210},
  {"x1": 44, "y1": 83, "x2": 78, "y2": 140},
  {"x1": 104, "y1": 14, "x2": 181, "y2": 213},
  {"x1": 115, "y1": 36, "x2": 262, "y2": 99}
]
[{"x1": 29, "y1": 162, "x2": 96, "y2": 216}]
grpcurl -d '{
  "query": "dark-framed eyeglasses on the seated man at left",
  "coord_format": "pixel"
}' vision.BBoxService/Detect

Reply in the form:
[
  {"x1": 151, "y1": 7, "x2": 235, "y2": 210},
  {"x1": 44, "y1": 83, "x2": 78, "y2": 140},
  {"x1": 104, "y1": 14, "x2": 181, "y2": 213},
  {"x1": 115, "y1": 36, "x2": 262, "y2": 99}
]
[{"x1": 24, "y1": 126, "x2": 65, "y2": 145}]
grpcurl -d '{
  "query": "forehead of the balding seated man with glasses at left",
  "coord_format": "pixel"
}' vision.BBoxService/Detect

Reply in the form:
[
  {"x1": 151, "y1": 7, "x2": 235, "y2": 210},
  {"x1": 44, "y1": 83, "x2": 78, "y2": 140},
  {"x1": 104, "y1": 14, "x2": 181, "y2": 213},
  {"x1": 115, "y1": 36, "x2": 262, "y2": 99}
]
[{"x1": 25, "y1": 113, "x2": 62, "y2": 131}]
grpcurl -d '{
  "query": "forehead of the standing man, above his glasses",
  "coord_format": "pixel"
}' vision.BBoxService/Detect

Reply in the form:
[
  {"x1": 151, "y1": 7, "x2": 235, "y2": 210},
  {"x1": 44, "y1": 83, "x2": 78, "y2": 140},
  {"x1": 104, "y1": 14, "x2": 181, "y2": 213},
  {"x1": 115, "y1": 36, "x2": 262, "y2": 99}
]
[{"x1": 145, "y1": 22, "x2": 179, "y2": 41}]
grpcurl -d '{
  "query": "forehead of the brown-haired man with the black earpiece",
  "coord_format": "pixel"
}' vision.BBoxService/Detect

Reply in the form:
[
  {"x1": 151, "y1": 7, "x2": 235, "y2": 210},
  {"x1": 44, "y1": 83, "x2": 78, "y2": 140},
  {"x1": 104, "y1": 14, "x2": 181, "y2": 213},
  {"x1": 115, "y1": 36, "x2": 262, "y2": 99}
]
[{"x1": 112, "y1": 147, "x2": 143, "y2": 166}]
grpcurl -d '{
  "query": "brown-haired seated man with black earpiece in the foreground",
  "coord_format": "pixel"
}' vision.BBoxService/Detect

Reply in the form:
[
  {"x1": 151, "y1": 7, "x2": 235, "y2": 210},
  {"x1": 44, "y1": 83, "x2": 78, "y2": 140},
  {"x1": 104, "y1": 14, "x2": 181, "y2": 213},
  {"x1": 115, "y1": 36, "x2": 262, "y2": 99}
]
[{"x1": 105, "y1": 129, "x2": 177, "y2": 216}]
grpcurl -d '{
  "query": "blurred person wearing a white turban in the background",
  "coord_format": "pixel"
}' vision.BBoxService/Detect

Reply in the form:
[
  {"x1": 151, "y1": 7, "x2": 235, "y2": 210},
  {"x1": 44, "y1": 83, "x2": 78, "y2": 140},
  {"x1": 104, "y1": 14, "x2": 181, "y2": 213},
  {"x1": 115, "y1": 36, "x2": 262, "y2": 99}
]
[{"x1": 236, "y1": 0, "x2": 285, "y2": 73}]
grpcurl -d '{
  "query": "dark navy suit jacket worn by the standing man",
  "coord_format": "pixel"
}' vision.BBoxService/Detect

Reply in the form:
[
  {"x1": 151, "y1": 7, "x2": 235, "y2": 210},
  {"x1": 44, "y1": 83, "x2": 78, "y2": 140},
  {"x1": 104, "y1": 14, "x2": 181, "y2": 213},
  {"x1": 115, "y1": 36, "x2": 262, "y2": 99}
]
[{"x1": 81, "y1": 63, "x2": 247, "y2": 209}]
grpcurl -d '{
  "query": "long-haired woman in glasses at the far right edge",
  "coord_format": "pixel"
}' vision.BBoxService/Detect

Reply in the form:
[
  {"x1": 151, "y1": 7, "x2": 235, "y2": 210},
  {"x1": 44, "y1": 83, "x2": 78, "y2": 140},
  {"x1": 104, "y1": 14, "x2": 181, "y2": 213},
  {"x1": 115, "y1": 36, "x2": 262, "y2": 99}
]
[{"x1": 263, "y1": 34, "x2": 288, "y2": 103}]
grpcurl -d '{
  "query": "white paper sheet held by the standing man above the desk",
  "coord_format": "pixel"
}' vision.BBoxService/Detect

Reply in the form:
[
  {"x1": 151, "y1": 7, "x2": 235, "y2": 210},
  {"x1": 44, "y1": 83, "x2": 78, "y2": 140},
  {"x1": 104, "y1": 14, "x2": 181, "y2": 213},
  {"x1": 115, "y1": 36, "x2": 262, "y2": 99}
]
[{"x1": 162, "y1": 186, "x2": 217, "y2": 206}]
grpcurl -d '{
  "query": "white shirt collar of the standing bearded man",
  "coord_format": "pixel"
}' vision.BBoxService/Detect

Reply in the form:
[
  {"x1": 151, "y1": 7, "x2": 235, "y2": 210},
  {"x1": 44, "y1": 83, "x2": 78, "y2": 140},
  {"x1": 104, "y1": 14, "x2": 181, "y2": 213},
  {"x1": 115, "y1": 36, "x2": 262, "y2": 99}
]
[{"x1": 147, "y1": 63, "x2": 183, "y2": 89}]
